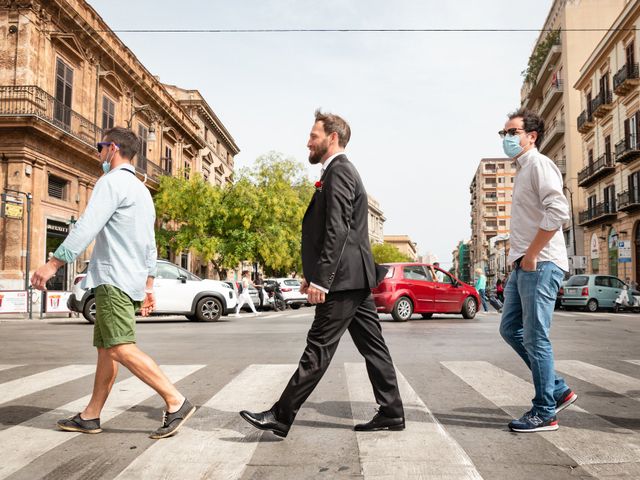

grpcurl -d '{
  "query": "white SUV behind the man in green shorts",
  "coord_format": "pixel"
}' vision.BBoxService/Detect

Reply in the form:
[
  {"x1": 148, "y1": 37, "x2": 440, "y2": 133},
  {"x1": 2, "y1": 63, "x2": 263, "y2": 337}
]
[{"x1": 67, "y1": 260, "x2": 238, "y2": 323}]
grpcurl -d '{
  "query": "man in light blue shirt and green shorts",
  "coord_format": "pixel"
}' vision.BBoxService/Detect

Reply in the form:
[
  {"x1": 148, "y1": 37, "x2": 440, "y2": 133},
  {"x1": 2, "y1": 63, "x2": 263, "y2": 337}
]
[{"x1": 31, "y1": 127, "x2": 196, "y2": 438}]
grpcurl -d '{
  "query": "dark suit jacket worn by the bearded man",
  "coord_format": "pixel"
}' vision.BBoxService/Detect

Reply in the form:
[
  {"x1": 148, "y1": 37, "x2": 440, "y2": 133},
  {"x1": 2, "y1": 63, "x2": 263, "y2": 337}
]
[{"x1": 302, "y1": 154, "x2": 376, "y2": 292}]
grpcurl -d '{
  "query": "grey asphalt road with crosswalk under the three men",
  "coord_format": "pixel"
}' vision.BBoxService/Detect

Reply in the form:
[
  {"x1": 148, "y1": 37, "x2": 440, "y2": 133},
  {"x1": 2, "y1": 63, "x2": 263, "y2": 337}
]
[{"x1": 0, "y1": 308, "x2": 640, "y2": 480}]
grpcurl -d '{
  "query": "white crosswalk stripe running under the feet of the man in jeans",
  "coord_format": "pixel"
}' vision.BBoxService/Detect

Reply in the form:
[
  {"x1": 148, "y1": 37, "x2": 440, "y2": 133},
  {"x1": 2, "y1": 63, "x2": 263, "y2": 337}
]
[{"x1": 442, "y1": 362, "x2": 640, "y2": 478}]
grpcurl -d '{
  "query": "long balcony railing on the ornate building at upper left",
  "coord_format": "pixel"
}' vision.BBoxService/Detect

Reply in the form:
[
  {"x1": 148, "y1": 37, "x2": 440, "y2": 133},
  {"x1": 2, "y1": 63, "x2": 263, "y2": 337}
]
[{"x1": 0, "y1": 85, "x2": 102, "y2": 147}]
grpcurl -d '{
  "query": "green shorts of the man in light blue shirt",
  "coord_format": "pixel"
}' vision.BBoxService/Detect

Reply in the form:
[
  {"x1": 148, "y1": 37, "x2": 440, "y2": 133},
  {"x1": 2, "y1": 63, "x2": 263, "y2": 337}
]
[{"x1": 93, "y1": 285, "x2": 140, "y2": 348}]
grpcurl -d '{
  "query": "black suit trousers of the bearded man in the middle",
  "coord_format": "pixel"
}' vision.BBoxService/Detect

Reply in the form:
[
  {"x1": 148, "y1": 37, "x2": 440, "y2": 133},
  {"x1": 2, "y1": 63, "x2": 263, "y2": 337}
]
[{"x1": 272, "y1": 289, "x2": 404, "y2": 425}]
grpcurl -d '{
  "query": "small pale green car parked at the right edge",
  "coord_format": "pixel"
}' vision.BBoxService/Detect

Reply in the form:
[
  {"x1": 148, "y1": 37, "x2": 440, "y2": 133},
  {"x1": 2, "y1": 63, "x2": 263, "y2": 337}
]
[{"x1": 562, "y1": 275, "x2": 640, "y2": 312}]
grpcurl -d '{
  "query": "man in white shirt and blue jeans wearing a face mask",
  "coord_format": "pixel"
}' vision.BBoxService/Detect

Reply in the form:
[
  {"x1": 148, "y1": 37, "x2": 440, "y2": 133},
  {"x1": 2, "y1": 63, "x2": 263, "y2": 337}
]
[{"x1": 499, "y1": 110, "x2": 578, "y2": 432}]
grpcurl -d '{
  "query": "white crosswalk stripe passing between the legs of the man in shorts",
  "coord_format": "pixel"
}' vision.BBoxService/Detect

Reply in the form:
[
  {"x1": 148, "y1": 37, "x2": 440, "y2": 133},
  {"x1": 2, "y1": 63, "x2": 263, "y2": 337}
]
[{"x1": 0, "y1": 365, "x2": 204, "y2": 479}]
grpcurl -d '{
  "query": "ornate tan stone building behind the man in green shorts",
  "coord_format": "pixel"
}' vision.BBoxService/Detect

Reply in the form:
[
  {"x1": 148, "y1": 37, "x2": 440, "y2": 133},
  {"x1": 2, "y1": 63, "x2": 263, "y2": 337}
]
[{"x1": 0, "y1": 0, "x2": 237, "y2": 290}]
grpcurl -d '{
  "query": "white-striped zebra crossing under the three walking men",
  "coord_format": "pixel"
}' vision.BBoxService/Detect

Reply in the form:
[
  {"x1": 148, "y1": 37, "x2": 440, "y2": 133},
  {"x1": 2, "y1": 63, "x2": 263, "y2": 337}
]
[{"x1": 0, "y1": 359, "x2": 640, "y2": 480}]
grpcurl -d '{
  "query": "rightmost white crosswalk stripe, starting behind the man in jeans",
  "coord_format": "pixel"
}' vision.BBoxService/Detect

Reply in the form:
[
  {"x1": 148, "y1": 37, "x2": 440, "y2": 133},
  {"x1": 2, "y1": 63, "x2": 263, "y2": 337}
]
[{"x1": 555, "y1": 360, "x2": 640, "y2": 400}]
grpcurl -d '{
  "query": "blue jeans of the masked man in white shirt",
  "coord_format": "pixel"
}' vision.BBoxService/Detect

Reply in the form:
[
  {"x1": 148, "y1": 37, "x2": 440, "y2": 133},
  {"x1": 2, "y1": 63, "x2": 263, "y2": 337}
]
[{"x1": 500, "y1": 262, "x2": 568, "y2": 419}]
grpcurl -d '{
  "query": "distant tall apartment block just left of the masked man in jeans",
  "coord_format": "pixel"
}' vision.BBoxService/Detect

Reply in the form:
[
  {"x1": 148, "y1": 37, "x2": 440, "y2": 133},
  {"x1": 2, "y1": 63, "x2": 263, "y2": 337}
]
[{"x1": 469, "y1": 158, "x2": 516, "y2": 270}]
